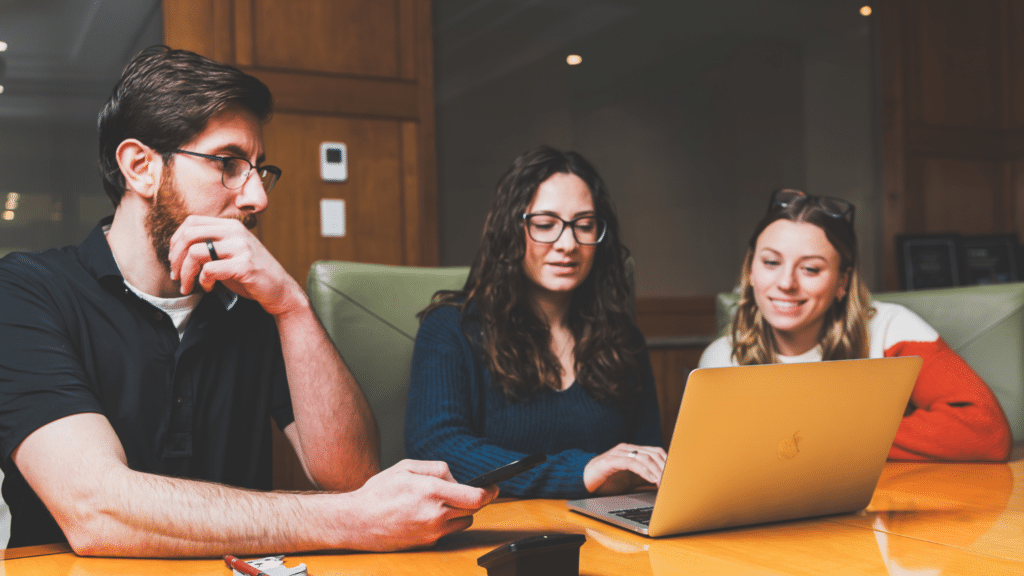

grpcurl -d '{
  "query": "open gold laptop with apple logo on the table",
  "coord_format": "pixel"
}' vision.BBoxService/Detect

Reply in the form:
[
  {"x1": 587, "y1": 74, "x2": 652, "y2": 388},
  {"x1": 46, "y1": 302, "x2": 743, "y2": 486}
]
[{"x1": 567, "y1": 356, "x2": 922, "y2": 536}]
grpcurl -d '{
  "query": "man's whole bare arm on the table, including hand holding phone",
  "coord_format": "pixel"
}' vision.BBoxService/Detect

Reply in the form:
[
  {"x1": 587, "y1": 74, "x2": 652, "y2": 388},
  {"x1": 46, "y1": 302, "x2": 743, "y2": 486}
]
[{"x1": 18, "y1": 413, "x2": 495, "y2": 558}]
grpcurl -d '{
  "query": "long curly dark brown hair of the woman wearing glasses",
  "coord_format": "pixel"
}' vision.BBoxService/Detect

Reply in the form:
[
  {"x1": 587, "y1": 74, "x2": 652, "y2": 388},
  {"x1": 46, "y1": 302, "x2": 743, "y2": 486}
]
[{"x1": 421, "y1": 146, "x2": 640, "y2": 403}]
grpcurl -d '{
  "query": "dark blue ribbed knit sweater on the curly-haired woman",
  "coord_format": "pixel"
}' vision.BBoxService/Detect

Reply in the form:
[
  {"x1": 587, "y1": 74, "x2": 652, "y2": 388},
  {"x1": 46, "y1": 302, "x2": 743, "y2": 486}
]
[{"x1": 406, "y1": 306, "x2": 662, "y2": 498}]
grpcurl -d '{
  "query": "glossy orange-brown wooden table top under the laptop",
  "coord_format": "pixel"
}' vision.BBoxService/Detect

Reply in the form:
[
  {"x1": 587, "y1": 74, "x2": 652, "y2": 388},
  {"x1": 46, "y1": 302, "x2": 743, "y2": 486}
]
[{"x1": 0, "y1": 444, "x2": 1024, "y2": 576}]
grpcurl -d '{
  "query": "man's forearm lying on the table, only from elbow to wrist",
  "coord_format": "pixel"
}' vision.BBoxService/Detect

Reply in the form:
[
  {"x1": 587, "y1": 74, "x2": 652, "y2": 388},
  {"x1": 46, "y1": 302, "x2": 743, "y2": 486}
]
[{"x1": 68, "y1": 468, "x2": 351, "y2": 558}]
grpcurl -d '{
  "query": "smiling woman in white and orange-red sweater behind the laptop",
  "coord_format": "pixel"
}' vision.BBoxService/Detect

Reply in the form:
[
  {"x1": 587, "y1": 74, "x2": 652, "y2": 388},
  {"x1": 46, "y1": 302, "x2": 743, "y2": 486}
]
[{"x1": 700, "y1": 189, "x2": 1013, "y2": 460}]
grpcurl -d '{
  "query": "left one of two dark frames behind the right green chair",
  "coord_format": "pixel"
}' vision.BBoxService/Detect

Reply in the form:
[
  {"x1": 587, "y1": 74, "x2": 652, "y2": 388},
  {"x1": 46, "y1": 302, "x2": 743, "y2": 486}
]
[{"x1": 896, "y1": 234, "x2": 961, "y2": 290}]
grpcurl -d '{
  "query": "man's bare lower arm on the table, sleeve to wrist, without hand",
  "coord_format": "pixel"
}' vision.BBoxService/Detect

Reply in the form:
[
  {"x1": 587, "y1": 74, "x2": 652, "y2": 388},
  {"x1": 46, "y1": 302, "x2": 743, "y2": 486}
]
[{"x1": 16, "y1": 412, "x2": 360, "y2": 557}]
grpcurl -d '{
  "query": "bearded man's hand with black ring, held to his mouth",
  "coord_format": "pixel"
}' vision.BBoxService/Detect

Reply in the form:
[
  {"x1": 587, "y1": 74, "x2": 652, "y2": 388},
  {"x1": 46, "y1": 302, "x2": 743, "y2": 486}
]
[{"x1": 169, "y1": 215, "x2": 305, "y2": 316}]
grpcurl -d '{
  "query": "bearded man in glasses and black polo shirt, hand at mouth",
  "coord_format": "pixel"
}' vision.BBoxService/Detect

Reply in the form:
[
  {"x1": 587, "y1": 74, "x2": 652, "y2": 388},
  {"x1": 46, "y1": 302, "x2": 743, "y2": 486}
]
[{"x1": 0, "y1": 46, "x2": 497, "y2": 557}]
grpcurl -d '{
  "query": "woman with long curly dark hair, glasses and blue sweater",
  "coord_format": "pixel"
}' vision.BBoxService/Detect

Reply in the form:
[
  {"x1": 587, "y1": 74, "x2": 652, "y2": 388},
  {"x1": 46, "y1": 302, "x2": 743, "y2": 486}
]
[{"x1": 406, "y1": 147, "x2": 666, "y2": 498}]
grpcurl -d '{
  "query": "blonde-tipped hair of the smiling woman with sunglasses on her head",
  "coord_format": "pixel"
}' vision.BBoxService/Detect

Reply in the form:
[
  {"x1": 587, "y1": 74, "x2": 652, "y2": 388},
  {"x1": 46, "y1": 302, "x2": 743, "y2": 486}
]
[{"x1": 731, "y1": 197, "x2": 874, "y2": 365}]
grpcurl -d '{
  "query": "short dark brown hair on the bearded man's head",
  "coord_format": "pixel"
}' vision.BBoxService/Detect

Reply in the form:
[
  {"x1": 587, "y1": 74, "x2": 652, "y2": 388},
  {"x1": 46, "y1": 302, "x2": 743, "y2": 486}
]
[{"x1": 97, "y1": 46, "x2": 273, "y2": 207}]
